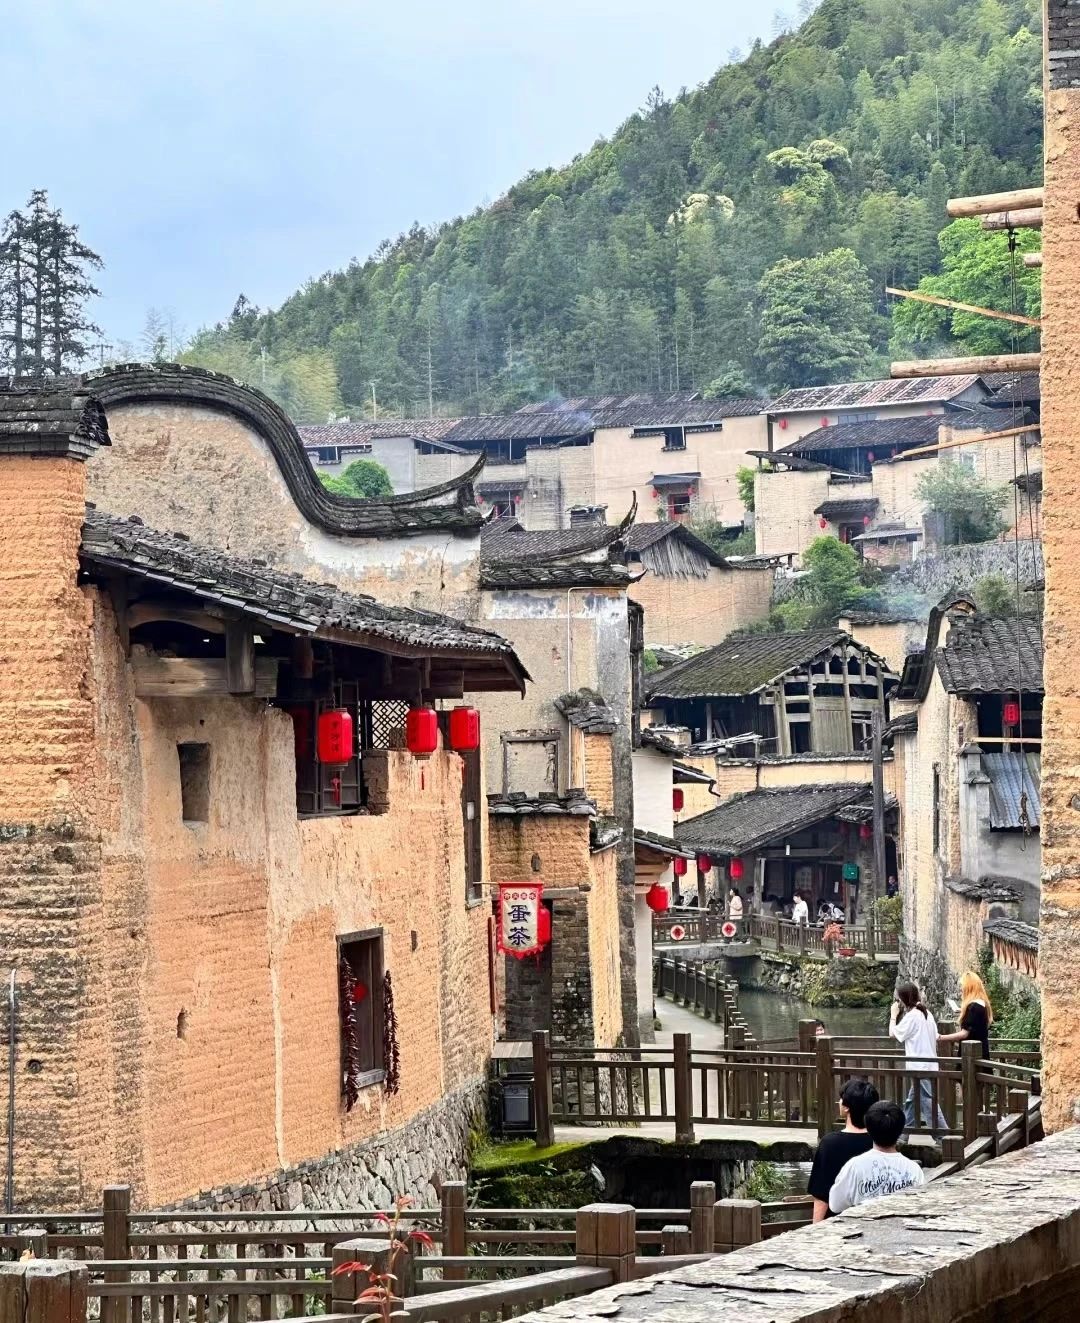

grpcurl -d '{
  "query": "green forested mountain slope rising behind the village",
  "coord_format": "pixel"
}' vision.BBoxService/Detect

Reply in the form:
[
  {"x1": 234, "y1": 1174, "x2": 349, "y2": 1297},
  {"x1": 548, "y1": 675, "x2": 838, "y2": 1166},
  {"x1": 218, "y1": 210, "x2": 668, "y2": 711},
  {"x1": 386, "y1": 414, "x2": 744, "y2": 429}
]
[{"x1": 181, "y1": 0, "x2": 1042, "y2": 419}]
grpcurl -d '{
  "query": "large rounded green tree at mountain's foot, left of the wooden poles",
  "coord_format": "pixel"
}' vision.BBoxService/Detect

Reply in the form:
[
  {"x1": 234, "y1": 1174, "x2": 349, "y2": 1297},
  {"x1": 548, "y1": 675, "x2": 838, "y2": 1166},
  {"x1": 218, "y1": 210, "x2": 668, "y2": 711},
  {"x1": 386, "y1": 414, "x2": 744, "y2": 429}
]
[{"x1": 758, "y1": 249, "x2": 875, "y2": 388}]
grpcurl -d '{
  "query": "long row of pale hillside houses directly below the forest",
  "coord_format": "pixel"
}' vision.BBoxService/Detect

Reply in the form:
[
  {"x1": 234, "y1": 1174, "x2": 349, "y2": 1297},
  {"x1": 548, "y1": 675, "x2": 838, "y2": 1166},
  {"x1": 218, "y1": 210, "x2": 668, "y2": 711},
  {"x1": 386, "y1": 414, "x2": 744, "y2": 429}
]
[{"x1": 304, "y1": 390, "x2": 766, "y2": 532}]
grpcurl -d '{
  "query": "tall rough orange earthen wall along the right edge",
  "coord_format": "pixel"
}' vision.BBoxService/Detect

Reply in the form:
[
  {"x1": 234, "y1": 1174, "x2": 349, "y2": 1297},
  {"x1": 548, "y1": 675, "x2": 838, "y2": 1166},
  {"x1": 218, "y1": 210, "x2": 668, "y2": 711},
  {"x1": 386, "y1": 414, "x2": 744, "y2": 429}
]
[{"x1": 1039, "y1": 0, "x2": 1080, "y2": 1127}]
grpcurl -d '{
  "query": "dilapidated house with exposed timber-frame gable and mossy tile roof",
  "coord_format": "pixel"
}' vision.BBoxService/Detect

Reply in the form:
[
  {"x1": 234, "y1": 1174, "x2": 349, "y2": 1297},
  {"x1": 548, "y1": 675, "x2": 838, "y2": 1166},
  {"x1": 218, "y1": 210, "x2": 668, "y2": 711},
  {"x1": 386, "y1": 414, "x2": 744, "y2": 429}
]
[{"x1": 645, "y1": 630, "x2": 895, "y2": 757}]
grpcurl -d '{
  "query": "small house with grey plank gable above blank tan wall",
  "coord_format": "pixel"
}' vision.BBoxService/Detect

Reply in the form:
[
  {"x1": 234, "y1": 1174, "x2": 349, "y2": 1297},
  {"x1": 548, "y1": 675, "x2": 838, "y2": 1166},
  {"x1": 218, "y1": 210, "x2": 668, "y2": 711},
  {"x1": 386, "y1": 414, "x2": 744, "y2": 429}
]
[{"x1": 625, "y1": 520, "x2": 774, "y2": 647}]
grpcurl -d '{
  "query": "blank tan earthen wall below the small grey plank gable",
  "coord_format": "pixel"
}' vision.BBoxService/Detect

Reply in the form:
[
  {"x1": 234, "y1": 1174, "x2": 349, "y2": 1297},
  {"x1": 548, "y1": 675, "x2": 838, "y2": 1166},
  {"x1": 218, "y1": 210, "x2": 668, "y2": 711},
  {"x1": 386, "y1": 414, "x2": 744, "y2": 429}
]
[{"x1": 629, "y1": 566, "x2": 773, "y2": 647}]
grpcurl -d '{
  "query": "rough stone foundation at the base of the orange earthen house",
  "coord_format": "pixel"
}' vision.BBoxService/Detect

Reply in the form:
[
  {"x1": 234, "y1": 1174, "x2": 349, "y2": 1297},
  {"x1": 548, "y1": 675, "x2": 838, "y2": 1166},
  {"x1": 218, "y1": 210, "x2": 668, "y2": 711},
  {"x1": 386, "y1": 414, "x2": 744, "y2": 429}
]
[{"x1": 177, "y1": 1081, "x2": 487, "y2": 1213}]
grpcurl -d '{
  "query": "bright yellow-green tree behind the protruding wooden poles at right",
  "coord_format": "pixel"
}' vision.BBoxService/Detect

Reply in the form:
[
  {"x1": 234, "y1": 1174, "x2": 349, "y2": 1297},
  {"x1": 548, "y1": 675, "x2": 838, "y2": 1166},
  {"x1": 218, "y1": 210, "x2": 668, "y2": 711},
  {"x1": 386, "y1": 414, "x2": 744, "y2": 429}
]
[{"x1": 892, "y1": 220, "x2": 1042, "y2": 355}]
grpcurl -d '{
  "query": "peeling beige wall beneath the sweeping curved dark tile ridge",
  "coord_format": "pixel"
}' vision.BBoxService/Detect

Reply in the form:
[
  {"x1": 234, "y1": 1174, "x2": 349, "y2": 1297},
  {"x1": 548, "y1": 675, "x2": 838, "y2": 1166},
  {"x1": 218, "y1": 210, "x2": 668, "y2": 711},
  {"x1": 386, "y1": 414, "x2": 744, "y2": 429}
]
[{"x1": 87, "y1": 404, "x2": 479, "y2": 618}]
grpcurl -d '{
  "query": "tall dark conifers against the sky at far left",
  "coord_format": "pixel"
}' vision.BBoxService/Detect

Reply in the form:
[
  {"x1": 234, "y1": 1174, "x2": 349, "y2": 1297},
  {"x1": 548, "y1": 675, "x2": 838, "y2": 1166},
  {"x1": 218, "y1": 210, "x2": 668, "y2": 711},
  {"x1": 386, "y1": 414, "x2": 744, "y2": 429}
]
[{"x1": 0, "y1": 189, "x2": 102, "y2": 378}]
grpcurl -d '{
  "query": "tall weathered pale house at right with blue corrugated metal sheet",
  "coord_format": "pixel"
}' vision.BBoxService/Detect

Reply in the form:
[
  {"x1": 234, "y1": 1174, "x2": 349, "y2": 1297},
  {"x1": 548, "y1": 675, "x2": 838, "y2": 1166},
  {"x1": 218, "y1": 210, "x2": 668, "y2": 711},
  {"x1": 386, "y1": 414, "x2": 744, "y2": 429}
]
[{"x1": 888, "y1": 597, "x2": 1043, "y2": 994}]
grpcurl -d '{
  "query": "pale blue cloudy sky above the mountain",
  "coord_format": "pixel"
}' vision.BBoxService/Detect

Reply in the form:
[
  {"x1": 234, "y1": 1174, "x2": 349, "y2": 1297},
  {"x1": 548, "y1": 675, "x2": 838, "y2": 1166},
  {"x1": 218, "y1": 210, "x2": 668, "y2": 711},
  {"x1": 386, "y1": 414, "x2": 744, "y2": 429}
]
[{"x1": 0, "y1": 0, "x2": 778, "y2": 344}]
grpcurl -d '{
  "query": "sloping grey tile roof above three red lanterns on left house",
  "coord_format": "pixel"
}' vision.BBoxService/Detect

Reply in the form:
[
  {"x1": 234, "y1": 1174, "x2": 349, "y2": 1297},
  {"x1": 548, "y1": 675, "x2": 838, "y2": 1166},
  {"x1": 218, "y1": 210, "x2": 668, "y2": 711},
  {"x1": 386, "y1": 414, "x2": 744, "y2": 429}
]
[{"x1": 81, "y1": 508, "x2": 528, "y2": 689}]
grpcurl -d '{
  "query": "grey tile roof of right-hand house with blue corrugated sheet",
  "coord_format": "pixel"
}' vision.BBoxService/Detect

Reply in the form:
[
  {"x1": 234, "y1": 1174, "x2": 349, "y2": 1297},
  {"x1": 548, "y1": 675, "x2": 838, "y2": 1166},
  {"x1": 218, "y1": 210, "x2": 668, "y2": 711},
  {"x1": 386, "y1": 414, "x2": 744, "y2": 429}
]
[{"x1": 934, "y1": 615, "x2": 1043, "y2": 693}]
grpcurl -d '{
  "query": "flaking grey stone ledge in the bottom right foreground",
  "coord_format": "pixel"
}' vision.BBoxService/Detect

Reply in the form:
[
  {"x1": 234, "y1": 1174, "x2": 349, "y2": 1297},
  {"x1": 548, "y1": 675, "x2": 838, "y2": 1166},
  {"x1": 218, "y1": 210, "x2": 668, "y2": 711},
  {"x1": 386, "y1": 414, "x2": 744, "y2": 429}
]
[{"x1": 513, "y1": 1127, "x2": 1080, "y2": 1323}]
